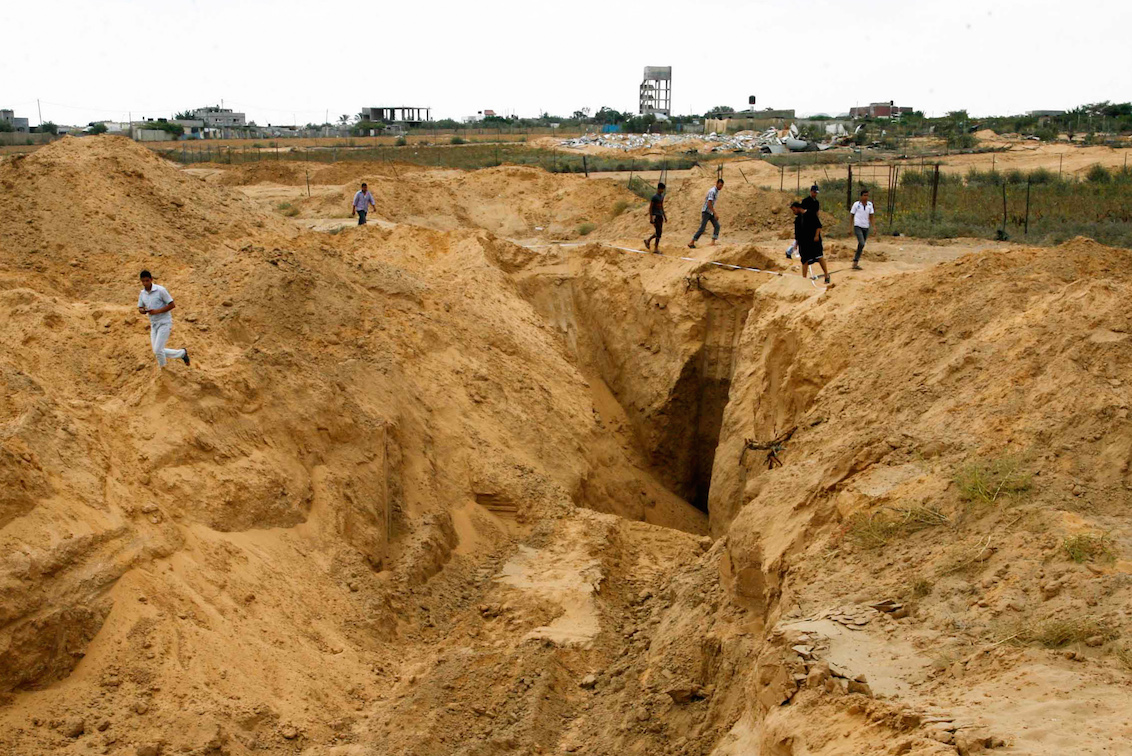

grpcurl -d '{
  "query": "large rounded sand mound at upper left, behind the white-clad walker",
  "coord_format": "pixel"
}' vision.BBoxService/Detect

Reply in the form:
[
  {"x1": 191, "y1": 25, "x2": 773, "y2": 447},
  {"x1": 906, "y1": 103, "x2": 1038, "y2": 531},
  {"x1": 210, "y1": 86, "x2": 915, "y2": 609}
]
[{"x1": 0, "y1": 137, "x2": 290, "y2": 295}]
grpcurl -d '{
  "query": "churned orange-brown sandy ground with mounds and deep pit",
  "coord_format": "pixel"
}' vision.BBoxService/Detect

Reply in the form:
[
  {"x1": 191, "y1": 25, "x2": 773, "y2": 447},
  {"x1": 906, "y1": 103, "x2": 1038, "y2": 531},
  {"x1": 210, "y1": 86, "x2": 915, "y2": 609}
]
[{"x1": 0, "y1": 137, "x2": 1132, "y2": 756}]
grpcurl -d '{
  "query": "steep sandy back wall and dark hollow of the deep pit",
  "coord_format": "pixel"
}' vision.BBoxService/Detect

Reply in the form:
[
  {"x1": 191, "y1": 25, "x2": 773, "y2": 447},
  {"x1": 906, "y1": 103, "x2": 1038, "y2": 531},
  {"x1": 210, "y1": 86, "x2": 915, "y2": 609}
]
[{"x1": 521, "y1": 246, "x2": 751, "y2": 513}]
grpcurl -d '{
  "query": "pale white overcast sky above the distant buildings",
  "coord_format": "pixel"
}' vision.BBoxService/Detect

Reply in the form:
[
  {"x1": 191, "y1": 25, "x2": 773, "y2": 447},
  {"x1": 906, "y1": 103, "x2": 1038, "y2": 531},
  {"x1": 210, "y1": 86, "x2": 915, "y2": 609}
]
[{"x1": 0, "y1": 0, "x2": 1132, "y2": 124}]
